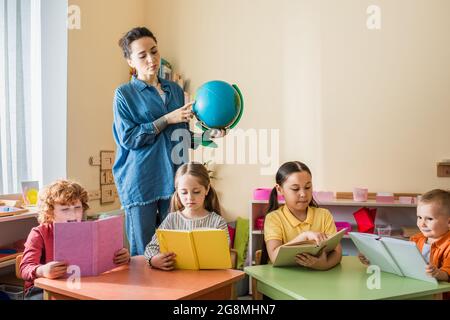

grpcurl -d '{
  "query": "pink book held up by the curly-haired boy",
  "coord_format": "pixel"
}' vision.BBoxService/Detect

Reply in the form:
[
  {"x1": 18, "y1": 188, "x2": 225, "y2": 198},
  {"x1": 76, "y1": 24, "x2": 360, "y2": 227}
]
[{"x1": 53, "y1": 216, "x2": 123, "y2": 277}]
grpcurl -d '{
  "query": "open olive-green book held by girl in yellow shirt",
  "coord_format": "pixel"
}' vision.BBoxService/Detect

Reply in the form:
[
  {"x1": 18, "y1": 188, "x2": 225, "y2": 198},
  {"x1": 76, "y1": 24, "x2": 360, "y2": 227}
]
[{"x1": 273, "y1": 229, "x2": 347, "y2": 267}]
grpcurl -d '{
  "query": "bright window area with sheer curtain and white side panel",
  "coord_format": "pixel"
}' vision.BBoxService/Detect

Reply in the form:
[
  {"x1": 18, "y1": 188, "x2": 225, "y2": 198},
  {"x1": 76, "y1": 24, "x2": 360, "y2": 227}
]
[{"x1": 0, "y1": 0, "x2": 68, "y2": 194}]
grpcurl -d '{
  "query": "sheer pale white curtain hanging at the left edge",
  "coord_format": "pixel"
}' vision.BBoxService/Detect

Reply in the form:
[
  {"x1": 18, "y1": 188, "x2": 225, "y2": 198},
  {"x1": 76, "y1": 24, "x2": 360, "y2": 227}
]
[{"x1": 0, "y1": 0, "x2": 32, "y2": 194}]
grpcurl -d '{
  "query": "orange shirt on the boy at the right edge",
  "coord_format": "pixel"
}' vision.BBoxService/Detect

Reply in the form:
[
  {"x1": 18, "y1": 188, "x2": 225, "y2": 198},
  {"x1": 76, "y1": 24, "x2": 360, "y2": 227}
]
[{"x1": 410, "y1": 231, "x2": 450, "y2": 300}]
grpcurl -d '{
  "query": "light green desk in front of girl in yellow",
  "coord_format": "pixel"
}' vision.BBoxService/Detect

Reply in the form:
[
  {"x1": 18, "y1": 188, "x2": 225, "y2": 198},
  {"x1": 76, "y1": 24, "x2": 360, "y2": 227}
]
[{"x1": 244, "y1": 257, "x2": 450, "y2": 300}]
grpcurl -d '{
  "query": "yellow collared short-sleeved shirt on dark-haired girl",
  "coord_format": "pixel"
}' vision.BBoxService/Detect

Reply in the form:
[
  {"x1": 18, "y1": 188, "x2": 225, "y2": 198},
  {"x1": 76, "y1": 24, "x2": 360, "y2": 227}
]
[{"x1": 264, "y1": 205, "x2": 337, "y2": 243}]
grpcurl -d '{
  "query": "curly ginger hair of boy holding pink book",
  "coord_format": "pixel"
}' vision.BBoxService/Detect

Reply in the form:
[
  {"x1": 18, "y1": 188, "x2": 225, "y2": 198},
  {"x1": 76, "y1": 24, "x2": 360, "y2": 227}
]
[{"x1": 38, "y1": 180, "x2": 89, "y2": 224}]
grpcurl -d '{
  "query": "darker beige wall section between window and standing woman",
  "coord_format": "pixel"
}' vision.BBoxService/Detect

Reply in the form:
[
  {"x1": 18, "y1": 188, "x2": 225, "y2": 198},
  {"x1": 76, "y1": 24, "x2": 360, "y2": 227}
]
[{"x1": 67, "y1": 0, "x2": 144, "y2": 213}]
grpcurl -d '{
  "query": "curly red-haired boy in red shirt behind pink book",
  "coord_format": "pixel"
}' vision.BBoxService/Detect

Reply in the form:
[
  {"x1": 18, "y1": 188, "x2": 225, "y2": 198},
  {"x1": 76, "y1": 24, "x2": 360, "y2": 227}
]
[{"x1": 20, "y1": 180, "x2": 130, "y2": 295}]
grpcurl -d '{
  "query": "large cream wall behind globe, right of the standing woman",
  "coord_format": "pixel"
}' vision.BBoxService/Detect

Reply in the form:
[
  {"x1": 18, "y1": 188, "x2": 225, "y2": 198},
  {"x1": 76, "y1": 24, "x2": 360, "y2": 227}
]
[{"x1": 145, "y1": 0, "x2": 450, "y2": 220}]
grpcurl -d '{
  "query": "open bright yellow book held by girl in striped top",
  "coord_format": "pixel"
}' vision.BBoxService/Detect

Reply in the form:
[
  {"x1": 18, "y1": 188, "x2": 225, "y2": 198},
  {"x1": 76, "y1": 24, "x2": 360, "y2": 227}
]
[{"x1": 156, "y1": 229, "x2": 231, "y2": 270}]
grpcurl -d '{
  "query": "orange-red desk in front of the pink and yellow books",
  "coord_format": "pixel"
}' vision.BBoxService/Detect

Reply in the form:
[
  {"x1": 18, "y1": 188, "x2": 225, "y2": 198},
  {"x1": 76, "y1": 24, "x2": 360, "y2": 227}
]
[{"x1": 35, "y1": 256, "x2": 245, "y2": 300}]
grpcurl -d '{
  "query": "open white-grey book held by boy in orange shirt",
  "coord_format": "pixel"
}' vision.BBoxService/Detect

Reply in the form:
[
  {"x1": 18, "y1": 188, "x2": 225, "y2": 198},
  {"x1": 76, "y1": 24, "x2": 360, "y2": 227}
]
[{"x1": 350, "y1": 232, "x2": 437, "y2": 285}]
